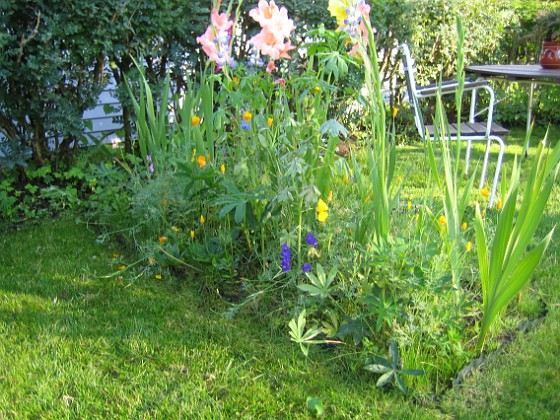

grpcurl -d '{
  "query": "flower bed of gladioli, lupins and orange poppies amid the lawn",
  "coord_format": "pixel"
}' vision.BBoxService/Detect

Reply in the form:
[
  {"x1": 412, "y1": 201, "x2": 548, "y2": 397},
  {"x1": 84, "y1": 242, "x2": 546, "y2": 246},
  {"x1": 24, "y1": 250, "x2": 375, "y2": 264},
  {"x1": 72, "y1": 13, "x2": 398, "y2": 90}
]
[{"x1": 83, "y1": 0, "x2": 560, "y2": 391}]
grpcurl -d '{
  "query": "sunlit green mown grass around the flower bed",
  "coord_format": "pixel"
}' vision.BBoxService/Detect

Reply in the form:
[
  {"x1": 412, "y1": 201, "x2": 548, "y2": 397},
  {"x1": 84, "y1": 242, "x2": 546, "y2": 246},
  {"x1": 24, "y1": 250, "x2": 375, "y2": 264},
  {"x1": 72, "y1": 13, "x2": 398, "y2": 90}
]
[{"x1": 0, "y1": 124, "x2": 560, "y2": 419}]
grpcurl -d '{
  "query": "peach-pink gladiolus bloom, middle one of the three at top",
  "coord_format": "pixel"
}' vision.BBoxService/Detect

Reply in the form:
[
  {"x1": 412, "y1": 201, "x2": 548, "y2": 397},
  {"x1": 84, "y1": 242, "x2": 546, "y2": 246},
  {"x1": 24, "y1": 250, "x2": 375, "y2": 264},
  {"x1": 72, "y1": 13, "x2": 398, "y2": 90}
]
[{"x1": 249, "y1": 0, "x2": 296, "y2": 62}]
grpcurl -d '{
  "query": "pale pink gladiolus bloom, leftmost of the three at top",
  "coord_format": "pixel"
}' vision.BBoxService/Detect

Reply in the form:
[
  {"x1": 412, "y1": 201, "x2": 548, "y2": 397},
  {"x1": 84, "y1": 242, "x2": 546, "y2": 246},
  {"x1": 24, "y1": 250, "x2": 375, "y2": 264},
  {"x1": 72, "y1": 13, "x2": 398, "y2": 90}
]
[{"x1": 196, "y1": 9, "x2": 234, "y2": 67}]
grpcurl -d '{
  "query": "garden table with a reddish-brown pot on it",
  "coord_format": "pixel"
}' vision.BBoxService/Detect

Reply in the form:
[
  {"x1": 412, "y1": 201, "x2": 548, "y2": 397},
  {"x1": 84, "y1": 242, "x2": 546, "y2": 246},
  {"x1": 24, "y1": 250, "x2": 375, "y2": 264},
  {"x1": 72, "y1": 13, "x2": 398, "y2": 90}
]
[{"x1": 465, "y1": 64, "x2": 560, "y2": 155}]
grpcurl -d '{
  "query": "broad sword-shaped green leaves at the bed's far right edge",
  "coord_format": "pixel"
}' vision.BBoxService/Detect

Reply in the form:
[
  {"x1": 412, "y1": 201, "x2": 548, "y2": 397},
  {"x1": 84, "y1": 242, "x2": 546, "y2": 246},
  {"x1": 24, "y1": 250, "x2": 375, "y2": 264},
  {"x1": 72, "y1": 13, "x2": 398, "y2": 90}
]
[{"x1": 475, "y1": 142, "x2": 560, "y2": 352}]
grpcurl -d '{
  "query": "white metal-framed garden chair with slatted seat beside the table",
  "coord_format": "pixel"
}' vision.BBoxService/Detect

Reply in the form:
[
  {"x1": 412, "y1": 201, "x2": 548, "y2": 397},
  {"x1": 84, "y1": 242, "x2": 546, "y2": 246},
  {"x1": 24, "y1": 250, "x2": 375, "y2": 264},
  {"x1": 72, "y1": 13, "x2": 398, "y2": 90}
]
[{"x1": 400, "y1": 44, "x2": 509, "y2": 207}]
